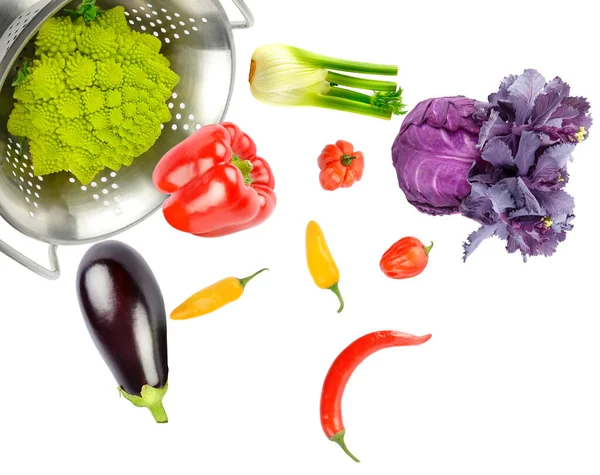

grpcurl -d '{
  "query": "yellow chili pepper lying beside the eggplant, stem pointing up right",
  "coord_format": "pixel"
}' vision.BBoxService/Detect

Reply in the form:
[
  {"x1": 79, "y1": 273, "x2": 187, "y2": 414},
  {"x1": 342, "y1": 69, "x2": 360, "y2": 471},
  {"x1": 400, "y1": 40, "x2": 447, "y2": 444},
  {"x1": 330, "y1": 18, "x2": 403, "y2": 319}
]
[{"x1": 171, "y1": 268, "x2": 268, "y2": 320}]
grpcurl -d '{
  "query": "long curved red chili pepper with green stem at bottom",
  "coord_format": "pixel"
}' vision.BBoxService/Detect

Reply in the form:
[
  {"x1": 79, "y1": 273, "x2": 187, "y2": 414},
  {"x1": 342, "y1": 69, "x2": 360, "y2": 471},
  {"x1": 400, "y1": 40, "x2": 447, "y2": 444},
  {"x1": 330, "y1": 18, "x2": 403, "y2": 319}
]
[{"x1": 321, "y1": 330, "x2": 431, "y2": 462}]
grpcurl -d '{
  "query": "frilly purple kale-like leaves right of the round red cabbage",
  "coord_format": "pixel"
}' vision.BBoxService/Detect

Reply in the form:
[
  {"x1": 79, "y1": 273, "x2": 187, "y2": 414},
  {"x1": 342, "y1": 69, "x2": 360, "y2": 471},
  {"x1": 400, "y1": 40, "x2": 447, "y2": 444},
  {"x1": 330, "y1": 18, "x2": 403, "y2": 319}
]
[{"x1": 460, "y1": 69, "x2": 592, "y2": 261}]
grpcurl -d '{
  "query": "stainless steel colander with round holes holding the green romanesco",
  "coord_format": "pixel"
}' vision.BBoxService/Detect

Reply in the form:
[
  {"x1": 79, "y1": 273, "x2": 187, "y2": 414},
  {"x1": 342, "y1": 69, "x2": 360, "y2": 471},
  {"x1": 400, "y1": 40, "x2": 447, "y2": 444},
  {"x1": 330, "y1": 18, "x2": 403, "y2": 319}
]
[{"x1": 0, "y1": 0, "x2": 254, "y2": 279}]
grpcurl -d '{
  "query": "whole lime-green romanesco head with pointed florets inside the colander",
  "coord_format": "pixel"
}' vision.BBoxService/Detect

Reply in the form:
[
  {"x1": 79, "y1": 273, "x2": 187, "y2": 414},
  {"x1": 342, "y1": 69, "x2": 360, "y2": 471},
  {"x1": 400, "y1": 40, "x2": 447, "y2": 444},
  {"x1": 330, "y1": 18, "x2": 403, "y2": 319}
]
[{"x1": 8, "y1": 6, "x2": 179, "y2": 185}]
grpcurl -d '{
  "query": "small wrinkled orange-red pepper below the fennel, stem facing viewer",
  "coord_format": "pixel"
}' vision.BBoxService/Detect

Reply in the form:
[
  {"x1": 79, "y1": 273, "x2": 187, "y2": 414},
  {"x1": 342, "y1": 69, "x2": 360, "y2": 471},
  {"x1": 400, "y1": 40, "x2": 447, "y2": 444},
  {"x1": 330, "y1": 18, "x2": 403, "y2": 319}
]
[{"x1": 317, "y1": 140, "x2": 365, "y2": 191}]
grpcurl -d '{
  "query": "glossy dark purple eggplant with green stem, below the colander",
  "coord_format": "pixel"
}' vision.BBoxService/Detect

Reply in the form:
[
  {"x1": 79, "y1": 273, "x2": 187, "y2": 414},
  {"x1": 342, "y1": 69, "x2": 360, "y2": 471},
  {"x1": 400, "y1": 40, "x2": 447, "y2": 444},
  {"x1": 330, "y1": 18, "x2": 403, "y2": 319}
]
[{"x1": 77, "y1": 240, "x2": 169, "y2": 423}]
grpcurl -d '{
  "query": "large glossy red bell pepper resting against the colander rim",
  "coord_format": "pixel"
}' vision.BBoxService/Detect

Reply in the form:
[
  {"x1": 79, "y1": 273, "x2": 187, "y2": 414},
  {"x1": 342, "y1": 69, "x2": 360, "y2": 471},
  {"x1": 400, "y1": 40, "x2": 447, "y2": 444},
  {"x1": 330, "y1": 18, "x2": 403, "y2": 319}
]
[{"x1": 152, "y1": 122, "x2": 277, "y2": 237}]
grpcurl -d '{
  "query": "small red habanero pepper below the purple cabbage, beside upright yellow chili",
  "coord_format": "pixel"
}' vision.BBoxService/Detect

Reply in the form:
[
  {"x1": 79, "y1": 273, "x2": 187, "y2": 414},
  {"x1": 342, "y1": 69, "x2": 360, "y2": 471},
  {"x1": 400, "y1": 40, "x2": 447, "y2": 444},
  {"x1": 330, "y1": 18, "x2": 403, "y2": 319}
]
[{"x1": 379, "y1": 237, "x2": 433, "y2": 279}]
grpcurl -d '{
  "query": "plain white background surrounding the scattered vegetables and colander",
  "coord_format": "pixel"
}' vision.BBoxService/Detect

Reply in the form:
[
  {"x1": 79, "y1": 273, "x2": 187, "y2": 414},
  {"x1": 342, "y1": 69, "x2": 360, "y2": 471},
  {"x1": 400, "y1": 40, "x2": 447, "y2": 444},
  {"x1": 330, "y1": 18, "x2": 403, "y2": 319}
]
[{"x1": 0, "y1": 0, "x2": 600, "y2": 475}]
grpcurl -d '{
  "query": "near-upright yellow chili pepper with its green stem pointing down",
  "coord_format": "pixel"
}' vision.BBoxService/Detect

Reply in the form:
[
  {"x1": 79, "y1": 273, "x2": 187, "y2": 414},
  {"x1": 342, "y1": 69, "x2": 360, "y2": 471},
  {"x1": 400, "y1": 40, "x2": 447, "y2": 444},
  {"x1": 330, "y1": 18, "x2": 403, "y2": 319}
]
[{"x1": 306, "y1": 221, "x2": 344, "y2": 313}]
